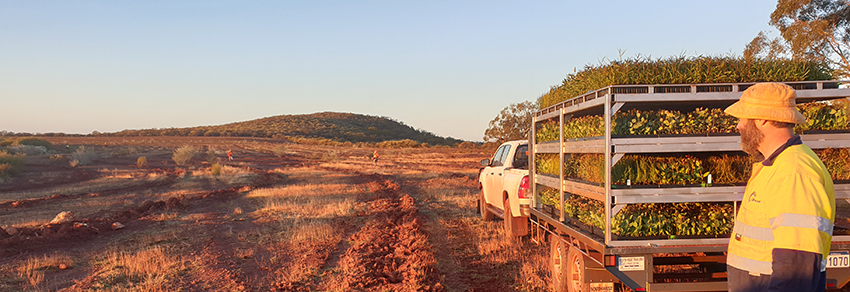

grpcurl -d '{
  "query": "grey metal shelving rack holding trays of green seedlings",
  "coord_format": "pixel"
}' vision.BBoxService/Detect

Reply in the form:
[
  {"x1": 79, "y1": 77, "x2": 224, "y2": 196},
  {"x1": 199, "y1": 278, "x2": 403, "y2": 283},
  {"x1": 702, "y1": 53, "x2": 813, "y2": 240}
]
[{"x1": 530, "y1": 80, "x2": 850, "y2": 249}]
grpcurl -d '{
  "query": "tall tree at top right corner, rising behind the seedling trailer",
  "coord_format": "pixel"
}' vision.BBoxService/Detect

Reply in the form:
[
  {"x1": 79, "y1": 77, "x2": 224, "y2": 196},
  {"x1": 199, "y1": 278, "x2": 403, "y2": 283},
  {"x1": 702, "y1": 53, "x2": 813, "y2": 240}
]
[{"x1": 744, "y1": 0, "x2": 850, "y2": 77}]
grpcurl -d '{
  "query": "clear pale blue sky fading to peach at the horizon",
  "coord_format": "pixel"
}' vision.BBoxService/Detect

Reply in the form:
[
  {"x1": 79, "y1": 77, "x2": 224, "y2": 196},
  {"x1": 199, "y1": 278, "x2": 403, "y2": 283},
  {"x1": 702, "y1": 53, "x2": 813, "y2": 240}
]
[{"x1": 0, "y1": 0, "x2": 778, "y2": 141}]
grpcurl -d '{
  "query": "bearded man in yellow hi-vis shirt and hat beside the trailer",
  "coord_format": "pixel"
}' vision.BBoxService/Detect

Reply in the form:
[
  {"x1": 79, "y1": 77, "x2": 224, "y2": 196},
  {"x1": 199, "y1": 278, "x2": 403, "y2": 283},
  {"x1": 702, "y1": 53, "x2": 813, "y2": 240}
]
[{"x1": 725, "y1": 83, "x2": 835, "y2": 291}]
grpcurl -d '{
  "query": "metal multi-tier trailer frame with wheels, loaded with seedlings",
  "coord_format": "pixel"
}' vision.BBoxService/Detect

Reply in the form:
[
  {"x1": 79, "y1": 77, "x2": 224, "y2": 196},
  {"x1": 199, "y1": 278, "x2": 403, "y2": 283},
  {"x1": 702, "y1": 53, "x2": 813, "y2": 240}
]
[{"x1": 529, "y1": 80, "x2": 850, "y2": 292}]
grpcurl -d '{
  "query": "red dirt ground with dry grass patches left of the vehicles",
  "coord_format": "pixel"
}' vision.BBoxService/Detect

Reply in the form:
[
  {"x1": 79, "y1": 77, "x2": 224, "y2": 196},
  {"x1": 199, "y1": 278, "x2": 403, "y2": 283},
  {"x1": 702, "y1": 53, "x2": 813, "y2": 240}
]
[{"x1": 0, "y1": 137, "x2": 548, "y2": 291}]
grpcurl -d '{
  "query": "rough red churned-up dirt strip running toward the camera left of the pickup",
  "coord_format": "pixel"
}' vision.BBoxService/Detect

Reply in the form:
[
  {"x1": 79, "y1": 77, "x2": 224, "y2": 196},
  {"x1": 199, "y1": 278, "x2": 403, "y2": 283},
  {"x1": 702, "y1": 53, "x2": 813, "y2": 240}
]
[{"x1": 312, "y1": 169, "x2": 445, "y2": 291}]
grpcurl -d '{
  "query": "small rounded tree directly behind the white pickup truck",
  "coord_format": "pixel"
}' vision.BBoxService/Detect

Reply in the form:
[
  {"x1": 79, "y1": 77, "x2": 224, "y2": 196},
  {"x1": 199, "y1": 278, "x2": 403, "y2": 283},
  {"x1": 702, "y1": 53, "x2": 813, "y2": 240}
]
[{"x1": 484, "y1": 101, "x2": 537, "y2": 144}]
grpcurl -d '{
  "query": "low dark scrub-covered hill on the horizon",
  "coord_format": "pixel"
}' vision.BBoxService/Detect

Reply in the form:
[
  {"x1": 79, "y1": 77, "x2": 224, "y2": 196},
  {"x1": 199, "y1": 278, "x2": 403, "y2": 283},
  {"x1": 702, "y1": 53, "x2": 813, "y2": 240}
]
[{"x1": 107, "y1": 112, "x2": 463, "y2": 145}]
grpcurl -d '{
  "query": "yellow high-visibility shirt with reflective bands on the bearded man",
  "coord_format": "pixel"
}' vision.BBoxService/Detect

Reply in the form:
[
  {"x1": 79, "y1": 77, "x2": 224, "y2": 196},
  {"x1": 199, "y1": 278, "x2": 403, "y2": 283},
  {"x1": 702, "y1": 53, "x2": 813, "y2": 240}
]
[{"x1": 726, "y1": 136, "x2": 835, "y2": 275}]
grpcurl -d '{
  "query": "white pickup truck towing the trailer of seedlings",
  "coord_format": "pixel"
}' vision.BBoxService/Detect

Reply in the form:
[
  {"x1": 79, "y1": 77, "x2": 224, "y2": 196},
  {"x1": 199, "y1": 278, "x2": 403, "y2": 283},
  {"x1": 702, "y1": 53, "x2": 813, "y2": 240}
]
[{"x1": 478, "y1": 140, "x2": 533, "y2": 239}]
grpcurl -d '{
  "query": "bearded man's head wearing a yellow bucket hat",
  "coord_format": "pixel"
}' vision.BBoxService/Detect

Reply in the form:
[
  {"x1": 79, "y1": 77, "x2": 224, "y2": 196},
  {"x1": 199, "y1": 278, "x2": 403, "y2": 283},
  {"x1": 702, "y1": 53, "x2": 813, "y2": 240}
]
[{"x1": 725, "y1": 83, "x2": 806, "y2": 160}]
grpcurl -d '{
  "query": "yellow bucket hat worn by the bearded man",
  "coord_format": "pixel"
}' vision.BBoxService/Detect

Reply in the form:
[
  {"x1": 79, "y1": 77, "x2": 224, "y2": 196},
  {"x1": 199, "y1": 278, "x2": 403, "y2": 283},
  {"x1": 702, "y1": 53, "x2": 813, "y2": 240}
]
[{"x1": 724, "y1": 82, "x2": 806, "y2": 124}]
